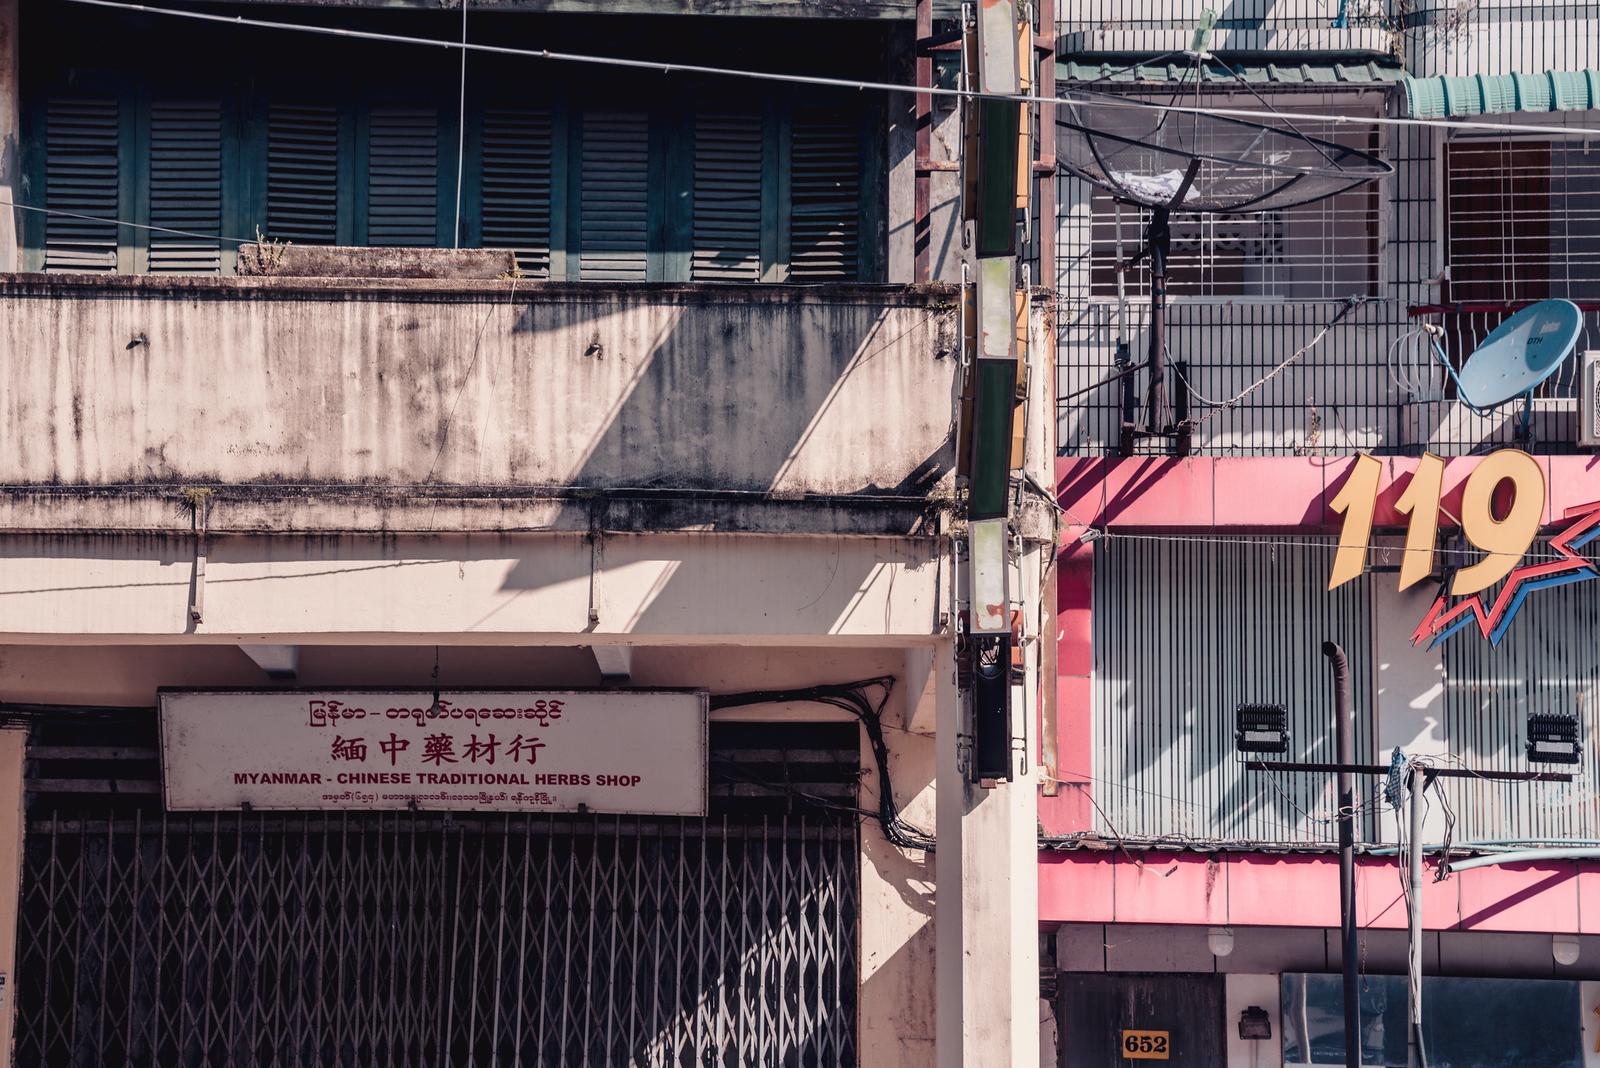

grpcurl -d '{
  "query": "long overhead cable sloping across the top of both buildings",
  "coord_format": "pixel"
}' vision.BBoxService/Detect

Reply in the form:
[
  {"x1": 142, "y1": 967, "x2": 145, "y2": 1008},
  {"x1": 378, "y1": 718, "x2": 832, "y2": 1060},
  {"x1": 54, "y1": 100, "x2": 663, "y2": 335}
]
[{"x1": 56, "y1": 0, "x2": 1600, "y2": 136}]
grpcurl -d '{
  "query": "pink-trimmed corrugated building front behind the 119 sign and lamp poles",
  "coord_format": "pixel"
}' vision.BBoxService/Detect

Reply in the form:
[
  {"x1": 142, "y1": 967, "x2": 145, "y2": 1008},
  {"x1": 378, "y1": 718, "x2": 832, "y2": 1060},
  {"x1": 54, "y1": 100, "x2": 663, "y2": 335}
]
[{"x1": 1038, "y1": 456, "x2": 1600, "y2": 1066}]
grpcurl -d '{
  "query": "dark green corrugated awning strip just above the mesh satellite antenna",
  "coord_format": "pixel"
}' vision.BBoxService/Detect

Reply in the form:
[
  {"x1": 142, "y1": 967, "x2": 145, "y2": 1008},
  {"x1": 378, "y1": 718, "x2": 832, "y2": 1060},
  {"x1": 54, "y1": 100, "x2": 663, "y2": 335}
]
[{"x1": 1056, "y1": 53, "x2": 1405, "y2": 88}]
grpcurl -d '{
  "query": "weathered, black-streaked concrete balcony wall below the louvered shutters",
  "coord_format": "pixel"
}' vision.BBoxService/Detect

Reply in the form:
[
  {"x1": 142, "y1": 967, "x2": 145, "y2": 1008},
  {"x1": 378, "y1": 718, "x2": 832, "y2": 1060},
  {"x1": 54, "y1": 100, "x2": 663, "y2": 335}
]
[{"x1": 0, "y1": 275, "x2": 957, "y2": 497}]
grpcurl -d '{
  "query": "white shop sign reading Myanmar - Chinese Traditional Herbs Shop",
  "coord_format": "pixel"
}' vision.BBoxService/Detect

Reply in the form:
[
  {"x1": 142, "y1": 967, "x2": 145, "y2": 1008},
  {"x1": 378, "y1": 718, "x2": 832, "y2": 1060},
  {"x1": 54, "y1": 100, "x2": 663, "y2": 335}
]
[{"x1": 160, "y1": 691, "x2": 706, "y2": 815}]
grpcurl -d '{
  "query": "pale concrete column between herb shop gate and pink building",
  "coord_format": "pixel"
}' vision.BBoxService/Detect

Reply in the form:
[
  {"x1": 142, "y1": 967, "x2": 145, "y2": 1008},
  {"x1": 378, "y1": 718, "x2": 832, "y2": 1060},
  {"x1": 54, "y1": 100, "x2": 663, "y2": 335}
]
[{"x1": 934, "y1": 550, "x2": 1040, "y2": 1068}]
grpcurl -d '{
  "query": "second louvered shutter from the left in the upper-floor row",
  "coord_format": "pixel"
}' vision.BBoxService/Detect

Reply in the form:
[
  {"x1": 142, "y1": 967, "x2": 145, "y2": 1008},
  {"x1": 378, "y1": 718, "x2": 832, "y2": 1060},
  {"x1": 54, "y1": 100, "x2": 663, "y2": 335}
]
[{"x1": 149, "y1": 101, "x2": 222, "y2": 275}]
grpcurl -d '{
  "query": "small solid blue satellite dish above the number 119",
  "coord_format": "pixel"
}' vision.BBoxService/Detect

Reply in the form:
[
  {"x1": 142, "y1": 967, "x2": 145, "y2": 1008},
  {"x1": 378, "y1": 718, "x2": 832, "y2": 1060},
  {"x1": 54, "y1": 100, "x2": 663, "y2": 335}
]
[{"x1": 1452, "y1": 301, "x2": 1584, "y2": 411}]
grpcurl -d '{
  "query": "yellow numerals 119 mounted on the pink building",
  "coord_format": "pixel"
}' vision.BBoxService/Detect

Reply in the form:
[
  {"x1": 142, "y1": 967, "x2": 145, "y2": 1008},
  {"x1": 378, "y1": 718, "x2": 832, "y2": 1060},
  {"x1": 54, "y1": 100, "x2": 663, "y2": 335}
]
[{"x1": 1328, "y1": 449, "x2": 1544, "y2": 596}]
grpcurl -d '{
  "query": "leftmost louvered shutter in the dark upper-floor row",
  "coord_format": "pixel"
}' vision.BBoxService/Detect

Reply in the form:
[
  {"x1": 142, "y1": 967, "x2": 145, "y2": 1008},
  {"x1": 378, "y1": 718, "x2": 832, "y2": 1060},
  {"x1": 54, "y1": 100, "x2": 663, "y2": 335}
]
[{"x1": 45, "y1": 98, "x2": 122, "y2": 272}]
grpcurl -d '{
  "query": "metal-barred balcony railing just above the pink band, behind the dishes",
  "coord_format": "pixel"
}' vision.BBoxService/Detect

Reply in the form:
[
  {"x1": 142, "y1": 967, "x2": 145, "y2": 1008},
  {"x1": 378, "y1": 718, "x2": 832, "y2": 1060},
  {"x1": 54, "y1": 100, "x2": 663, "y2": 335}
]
[{"x1": 1058, "y1": 301, "x2": 1600, "y2": 456}]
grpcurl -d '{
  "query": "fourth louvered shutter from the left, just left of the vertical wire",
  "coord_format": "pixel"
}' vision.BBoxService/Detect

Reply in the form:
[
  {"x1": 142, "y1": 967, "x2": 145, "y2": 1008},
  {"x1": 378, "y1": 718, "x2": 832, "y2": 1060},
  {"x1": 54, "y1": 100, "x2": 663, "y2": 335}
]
[{"x1": 366, "y1": 107, "x2": 438, "y2": 248}]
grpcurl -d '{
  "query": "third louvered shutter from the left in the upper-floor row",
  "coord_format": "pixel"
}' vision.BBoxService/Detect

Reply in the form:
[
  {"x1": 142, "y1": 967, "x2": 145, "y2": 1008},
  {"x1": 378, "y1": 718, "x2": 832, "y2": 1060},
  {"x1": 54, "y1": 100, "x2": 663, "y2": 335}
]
[{"x1": 267, "y1": 104, "x2": 339, "y2": 245}]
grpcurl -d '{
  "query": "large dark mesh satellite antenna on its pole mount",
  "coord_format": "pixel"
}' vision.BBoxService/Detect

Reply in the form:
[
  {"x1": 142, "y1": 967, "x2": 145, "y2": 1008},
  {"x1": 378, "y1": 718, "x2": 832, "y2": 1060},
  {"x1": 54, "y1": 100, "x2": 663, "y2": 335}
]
[{"x1": 1056, "y1": 23, "x2": 1394, "y2": 452}]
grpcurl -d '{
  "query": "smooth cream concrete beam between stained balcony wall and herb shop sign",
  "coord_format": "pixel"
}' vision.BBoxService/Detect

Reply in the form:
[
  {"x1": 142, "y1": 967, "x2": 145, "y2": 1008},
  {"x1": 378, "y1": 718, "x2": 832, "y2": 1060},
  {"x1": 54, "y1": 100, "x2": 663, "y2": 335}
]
[{"x1": 0, "y1": 534, "x2": 947, "y2": 646}]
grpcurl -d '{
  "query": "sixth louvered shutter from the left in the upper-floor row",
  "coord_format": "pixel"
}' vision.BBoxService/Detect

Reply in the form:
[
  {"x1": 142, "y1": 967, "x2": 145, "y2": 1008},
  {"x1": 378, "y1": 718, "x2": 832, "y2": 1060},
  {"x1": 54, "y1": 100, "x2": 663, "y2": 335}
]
[{"x1": 578, "y1": 112, "x2": 650, "y2": 281}]
